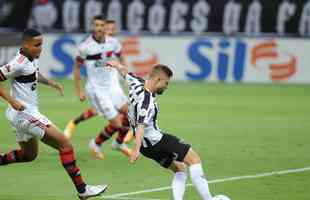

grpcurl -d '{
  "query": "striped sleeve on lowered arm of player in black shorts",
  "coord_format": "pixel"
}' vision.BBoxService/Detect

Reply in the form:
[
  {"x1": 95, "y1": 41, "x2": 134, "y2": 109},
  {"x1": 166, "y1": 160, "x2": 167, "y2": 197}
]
[{"x1": 137, "y1": 91, "x2": 152, "y2": 125}]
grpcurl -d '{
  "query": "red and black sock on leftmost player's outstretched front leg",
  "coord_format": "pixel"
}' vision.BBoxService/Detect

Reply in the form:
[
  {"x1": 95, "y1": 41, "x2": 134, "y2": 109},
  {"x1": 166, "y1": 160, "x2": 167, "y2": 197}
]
[{"x1": 59, "y1": 150, "x2": 86, "y2": 193}]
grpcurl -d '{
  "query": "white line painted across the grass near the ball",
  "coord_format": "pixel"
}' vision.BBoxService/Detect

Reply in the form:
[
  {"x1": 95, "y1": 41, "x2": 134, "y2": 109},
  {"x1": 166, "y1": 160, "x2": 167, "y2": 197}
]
[{"x1": 101, "y1": 166, "x2": 310, "y2": 199}]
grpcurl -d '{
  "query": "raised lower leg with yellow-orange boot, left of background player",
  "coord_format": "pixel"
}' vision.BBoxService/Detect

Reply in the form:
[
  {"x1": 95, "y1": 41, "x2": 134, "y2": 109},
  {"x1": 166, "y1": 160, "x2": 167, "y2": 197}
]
[{"x1": 64, "y1": 108, "x2": 97, "y2": 139}]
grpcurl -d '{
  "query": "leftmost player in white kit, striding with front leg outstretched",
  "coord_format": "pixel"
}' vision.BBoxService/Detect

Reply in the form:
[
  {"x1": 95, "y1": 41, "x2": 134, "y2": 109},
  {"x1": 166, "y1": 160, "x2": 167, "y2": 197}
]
[{"x1": 0, "y1": 29, "x2": 107, "y2": 199}]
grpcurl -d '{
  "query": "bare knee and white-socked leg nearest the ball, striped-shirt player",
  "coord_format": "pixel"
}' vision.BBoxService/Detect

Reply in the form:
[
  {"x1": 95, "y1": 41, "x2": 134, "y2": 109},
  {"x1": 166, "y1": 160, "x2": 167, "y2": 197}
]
[{"x1": 183, "y1": 148, "x2": 212, "y2": 200}]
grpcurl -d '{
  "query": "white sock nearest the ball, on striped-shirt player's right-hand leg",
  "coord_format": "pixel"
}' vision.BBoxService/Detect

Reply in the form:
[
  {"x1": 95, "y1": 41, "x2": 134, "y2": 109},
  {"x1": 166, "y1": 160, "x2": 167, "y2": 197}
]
[{"x1": 189, "y1": 163, "x2": 212, "y2": 200}]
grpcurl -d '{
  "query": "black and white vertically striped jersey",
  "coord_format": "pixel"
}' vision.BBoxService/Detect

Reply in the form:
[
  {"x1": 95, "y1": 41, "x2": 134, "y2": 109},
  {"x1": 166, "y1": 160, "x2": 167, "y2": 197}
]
[{"x1": 126, "y1": 73, "x2": 163, "y2": 147}]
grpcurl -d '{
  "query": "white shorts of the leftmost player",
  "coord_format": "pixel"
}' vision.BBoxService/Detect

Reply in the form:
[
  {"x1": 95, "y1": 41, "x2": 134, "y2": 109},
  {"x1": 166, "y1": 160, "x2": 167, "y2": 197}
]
[{"x1": 6, "y1": 108, "x2": 51, "y2": 142}]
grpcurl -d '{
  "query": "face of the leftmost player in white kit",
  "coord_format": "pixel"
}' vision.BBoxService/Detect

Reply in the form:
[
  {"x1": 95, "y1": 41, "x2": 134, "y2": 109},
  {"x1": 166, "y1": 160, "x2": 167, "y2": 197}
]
[{"x1": 23, "y1": 35, "x2": 43, "y2": 58}]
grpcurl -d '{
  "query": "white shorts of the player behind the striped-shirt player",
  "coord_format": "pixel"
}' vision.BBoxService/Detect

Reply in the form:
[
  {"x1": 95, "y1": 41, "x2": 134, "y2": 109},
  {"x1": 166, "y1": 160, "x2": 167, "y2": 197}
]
[{"x1": 86, "y1": 85, "x2": 128, "y2": 120}]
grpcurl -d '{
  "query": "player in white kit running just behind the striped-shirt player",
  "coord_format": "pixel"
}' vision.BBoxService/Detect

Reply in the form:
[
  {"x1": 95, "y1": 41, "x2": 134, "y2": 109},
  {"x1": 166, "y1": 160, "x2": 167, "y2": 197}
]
[{"x1": 64, "y1": 15, "x2": 131, "y2": 159}]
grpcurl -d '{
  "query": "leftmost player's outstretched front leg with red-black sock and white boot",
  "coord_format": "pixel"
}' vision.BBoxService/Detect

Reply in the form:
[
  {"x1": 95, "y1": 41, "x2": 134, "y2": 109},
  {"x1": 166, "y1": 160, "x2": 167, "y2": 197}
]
[{"x1": 41, "y1": 125, "x2": 107, "y2": 199}]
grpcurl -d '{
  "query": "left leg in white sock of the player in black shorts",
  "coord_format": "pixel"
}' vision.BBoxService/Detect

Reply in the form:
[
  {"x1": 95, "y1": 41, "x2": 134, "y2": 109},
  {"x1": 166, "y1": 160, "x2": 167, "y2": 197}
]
[{"x1": 169, "y1": 161, "x2": 187, "y2": 200}]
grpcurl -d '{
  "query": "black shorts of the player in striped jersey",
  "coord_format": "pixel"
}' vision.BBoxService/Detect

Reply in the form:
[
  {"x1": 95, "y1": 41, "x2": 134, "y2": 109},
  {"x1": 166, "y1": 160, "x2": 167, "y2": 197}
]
[{"x1": 140, "y1": 134, "x2": 191, "y2": 168}]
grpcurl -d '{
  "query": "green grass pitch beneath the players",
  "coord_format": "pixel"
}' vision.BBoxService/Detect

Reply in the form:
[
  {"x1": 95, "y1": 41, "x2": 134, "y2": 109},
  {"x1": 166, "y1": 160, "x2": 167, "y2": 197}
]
[{"x1": 0, "y1": 81, "x2": 310, "y2": 200}]
